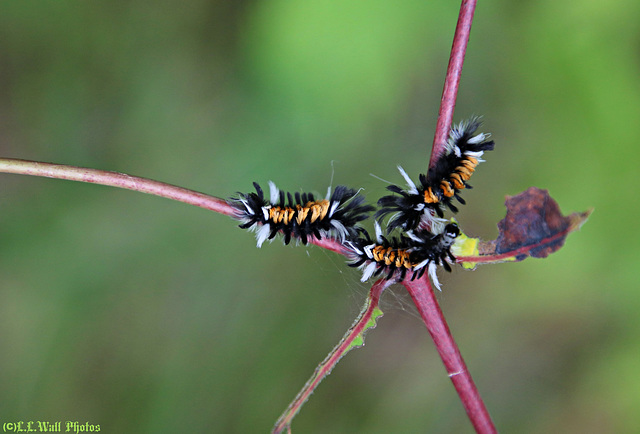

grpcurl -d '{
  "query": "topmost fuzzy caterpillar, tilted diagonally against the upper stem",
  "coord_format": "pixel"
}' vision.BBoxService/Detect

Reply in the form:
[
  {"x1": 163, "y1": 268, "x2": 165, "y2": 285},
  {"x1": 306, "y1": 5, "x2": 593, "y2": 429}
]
[{"x1": 375, "y1": 117, "x2": 494, "y2": 231}]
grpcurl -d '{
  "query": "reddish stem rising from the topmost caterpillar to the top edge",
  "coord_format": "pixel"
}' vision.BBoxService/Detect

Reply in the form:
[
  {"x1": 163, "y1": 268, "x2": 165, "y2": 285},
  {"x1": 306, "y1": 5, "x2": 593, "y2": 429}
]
[{"x1": 429, "y1": 0, "x2": 476, "y2": 168}]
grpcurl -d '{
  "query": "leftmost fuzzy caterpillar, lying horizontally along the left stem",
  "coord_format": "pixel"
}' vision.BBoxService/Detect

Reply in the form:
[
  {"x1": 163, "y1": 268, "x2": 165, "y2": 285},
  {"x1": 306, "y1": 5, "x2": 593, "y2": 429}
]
[{"x1": 227, "y1": 181, "x2": 374, "y2": 247}]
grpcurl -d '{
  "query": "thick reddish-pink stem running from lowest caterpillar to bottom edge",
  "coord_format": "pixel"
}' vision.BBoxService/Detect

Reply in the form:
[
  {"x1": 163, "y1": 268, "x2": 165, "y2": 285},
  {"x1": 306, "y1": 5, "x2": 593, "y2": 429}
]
[{"x1": 403, "y1": 277, "x2": 497, "y2": 434}]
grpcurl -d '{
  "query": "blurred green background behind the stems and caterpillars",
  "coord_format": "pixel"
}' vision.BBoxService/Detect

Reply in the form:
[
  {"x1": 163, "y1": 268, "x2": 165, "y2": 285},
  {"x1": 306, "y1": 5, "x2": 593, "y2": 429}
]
[{"x1": 0, "y1": 0, "x2": 640, "y2": 433}]
